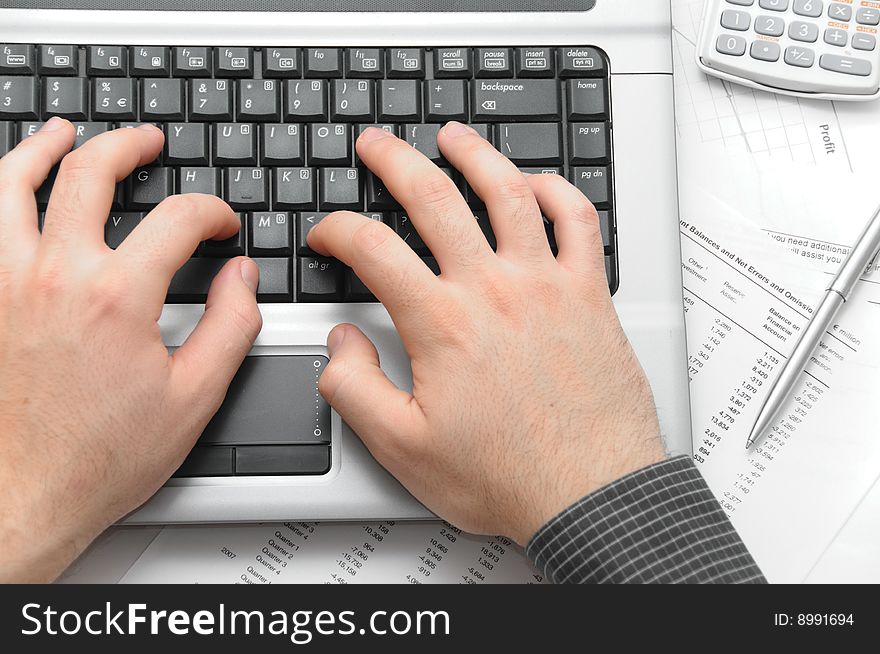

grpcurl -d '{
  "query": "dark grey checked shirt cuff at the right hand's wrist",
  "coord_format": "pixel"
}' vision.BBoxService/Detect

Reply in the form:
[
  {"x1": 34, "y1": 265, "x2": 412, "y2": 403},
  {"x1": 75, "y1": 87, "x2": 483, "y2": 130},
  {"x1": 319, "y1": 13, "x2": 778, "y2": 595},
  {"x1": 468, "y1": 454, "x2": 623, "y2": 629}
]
[{"x1": 526, "y1": 456, "x2": 766, "y2": 584}]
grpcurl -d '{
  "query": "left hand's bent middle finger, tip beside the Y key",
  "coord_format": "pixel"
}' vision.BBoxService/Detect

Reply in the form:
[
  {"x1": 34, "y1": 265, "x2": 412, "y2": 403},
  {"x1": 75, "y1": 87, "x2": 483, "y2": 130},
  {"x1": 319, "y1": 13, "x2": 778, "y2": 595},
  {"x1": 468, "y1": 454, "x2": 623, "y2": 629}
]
[{"x1": 41, "y1": 125, "x2": 165, "y2": 247}]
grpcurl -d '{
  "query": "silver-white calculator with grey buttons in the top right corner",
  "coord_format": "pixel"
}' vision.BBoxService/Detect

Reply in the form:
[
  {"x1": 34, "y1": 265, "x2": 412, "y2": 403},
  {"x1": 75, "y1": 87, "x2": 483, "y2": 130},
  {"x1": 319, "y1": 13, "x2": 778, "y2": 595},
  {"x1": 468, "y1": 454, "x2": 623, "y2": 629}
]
[{"x1": 697, "y1": 0, "x2": 880, "y2": 100}]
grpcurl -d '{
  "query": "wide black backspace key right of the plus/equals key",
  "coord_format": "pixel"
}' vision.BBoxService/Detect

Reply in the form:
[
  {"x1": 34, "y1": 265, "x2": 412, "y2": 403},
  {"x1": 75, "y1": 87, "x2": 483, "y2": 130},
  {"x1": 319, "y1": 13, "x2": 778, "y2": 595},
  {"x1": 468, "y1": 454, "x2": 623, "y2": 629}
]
[{"x1": 471, "y1": 79, "x2": 562, "y2": 122}]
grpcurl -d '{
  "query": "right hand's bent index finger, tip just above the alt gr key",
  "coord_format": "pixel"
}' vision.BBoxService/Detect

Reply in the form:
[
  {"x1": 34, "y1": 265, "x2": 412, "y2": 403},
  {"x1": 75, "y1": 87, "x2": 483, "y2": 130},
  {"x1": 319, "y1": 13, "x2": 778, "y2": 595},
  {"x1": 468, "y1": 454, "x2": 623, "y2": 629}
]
[{"x1": 308, "y1": 211, "x2": 444, "y2": 326}]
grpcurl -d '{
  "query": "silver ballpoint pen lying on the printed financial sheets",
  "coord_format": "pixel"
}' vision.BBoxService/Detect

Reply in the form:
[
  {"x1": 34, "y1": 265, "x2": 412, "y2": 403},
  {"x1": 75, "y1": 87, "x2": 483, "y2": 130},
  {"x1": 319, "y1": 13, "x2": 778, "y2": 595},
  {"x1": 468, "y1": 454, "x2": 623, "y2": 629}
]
[{"x1": 746, "y1": 207, "x2": 880, "y2": 449}]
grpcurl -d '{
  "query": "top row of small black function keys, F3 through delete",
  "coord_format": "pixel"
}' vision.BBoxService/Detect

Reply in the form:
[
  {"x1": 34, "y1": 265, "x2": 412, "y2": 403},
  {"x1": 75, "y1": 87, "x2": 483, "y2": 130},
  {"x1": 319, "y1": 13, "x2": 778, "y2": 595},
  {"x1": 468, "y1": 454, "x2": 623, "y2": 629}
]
[{"x1": 0, "y1": 43, "x2": 608, "y2": 79}]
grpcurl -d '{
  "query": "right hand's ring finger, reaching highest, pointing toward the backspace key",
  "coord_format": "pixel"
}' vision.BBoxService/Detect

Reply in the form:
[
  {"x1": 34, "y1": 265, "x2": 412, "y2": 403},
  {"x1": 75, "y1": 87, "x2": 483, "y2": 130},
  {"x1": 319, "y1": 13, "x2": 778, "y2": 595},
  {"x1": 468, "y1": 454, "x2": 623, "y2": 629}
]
[{"x1": 437, "y1": 122, "x2": 552, "y2": 260}]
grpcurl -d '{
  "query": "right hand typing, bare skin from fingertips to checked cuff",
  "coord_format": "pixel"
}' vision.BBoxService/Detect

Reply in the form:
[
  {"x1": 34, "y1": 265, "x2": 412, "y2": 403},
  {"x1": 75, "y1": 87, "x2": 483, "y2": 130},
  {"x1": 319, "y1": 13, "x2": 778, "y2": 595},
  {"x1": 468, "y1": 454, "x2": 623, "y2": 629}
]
[{"x1": 309, "y1": 123, "x2": 665, "y2": 544}]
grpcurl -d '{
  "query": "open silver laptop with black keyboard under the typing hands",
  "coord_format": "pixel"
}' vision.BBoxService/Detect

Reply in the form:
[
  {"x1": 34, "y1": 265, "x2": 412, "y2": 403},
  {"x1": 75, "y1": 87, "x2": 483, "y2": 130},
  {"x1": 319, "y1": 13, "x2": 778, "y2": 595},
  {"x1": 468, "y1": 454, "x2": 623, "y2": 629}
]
[{"x1": 0, "y1": 0, "x2": 691, "y2": 524}]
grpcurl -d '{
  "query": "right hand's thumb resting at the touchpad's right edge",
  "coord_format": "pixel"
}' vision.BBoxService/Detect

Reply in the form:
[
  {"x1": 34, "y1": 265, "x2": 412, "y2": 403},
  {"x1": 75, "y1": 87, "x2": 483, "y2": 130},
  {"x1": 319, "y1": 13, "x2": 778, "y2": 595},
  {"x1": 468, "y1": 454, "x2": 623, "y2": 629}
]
[{"x1": 318, "y1": 324, "x2": 424, "y2": 462}]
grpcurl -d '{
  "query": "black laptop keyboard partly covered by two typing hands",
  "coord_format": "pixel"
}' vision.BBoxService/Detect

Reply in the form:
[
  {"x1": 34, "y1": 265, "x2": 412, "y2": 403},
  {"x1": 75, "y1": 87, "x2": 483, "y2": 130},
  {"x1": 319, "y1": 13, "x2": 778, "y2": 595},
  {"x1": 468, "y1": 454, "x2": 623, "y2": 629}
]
[{"x1": 0, "y1": 43, "x2": 618, "y2": 303}]
